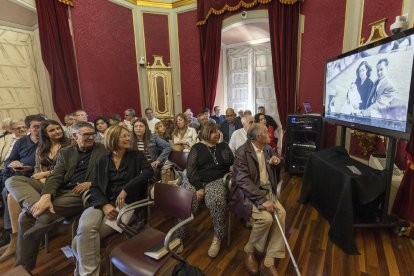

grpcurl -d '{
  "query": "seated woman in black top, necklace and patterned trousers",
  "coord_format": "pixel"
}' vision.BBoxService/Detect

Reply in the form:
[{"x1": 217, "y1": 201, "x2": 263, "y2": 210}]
[{"x1": 187, "y1": 123, "x2": 234, "y2": 258}]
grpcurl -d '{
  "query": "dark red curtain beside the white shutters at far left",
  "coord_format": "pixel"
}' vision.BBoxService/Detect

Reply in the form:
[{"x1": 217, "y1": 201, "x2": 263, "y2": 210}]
[{"x1": 36, "y1": 0, "x2": 81, "y2": 121}]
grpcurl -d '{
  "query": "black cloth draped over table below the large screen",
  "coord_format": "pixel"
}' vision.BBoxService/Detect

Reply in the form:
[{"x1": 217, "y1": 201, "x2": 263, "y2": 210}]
[{"x1": 299, "y1": 147, "x2": 386, "y2": 255}]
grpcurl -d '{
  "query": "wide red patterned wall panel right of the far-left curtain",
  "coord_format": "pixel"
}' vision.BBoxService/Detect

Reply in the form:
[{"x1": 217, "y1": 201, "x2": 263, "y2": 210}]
[{"x1": 72, "y1": 0, "x2": 140, "y2": 120}]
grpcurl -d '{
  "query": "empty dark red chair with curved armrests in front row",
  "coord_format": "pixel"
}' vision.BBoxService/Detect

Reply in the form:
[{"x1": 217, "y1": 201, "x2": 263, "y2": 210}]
[{"x1": 109, "y1": 183, "x2": 194, "y2": 275}]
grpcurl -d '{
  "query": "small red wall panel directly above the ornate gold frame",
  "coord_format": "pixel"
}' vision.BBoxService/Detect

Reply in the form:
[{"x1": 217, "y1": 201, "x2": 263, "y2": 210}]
[{"x1": 143, "y1": 13, "x2": 170, "y2": 65}]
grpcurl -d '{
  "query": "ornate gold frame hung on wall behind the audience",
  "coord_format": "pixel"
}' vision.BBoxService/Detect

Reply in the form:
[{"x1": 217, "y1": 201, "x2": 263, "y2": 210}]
[{"x1": 146, "y1": 55, "x2": 174, "y2": 119}]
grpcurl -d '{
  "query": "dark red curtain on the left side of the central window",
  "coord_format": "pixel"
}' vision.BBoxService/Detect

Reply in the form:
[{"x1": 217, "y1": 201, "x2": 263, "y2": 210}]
[{"x1": 199, "y1": 12, "x2": 223, "y2": 109}]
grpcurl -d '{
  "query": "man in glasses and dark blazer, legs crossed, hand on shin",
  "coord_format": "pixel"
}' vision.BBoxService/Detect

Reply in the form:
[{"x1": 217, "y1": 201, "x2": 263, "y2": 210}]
[{"x1": 7, "y1": 122, "x2": 106, "y2": 271}]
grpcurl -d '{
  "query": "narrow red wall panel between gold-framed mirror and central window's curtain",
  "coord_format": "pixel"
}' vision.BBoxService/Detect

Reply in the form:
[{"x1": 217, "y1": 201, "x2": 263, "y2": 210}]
[{"x1": 178, "y1": 10, "x2": 203, "y2": 115}]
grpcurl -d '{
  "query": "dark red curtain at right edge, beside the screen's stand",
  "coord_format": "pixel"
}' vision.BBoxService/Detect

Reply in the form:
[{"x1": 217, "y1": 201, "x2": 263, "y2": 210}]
[{"x1": 392, "y1": 135, "x2": 414, "y2": 223}]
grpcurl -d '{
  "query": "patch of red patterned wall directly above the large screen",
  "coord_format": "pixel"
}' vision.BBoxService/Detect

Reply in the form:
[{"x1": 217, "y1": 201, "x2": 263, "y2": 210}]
[{"x1": 361, "y1": 0, "x2": 403, "y2": 43}]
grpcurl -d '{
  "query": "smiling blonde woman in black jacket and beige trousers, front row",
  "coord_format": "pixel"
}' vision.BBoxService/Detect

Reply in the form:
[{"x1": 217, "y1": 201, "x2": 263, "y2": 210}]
[{"x1": 72, "y1": 126, "x2": 153, "y2": 275}]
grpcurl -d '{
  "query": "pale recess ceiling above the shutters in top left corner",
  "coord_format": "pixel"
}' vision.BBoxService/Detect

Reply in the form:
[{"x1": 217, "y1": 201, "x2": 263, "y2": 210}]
[{"x1": 0, "y1": 0, "x2": 36, "y2": 28}]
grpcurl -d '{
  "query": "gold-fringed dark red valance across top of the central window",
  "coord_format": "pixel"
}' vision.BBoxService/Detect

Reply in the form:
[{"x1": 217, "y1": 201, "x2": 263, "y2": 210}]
[{"x1": 197, "y1": 0, "x2": 299, "y2": 26}]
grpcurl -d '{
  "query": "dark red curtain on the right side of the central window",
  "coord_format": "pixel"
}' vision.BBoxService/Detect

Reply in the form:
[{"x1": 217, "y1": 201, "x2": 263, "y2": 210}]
[{"x1": 268, "y1": 1, "x2": 299, "y2": 130}]
